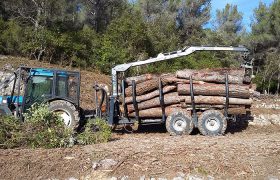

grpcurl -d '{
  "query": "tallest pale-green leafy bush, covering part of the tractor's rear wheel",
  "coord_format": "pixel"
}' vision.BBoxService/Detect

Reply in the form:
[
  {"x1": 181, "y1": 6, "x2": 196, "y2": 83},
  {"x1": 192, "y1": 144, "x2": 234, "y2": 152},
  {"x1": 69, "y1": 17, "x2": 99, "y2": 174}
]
[{"x1": 23, "y1": 104, "x2": 74, "y2": 148}]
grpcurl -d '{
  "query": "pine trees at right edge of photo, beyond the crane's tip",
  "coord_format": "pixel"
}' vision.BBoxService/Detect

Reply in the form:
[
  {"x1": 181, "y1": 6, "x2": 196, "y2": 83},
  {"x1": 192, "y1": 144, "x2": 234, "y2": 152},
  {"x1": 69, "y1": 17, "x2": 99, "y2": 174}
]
[{"x1": 248, "y1": 0, "x2": 280, "y2": 94}]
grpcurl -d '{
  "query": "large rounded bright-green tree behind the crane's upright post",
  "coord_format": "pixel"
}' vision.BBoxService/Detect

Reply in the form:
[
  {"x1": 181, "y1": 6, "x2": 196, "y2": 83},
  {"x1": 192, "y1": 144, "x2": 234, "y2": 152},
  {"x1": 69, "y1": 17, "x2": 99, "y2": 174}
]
[{"x1": 97, "y1": 8, "x2": 149, "y2": 73}]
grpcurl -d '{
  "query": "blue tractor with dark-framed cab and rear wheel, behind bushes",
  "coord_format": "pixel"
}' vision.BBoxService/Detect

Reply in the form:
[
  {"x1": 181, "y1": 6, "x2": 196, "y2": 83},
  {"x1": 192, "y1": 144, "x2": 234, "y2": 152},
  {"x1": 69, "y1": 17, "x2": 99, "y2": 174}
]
[{"x1": 0, "y1": 67, "x2": 80, "y2": 128}]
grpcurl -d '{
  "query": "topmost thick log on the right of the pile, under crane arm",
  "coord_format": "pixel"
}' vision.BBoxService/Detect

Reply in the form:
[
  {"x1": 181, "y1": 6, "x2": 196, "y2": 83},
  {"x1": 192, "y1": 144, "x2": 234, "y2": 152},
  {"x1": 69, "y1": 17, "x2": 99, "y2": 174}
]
[{"x1": 176, "y1": 69, "x2": 245, "y2": 84}]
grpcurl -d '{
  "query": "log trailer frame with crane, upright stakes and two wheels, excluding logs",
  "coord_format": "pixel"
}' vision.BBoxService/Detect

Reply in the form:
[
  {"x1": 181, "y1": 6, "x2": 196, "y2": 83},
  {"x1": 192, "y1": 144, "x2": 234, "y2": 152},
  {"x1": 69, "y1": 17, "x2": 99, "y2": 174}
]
[{"x1": 94, "y1": 46, "x2": 253, "y2": 136}]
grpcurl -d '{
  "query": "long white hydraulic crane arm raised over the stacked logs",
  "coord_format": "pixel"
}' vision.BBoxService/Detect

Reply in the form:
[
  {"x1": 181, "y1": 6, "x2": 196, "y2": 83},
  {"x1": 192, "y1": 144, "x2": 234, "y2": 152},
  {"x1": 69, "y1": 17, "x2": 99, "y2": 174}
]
[{"x1": 112, "y1": 46, "x2": 249, "y2": 96}]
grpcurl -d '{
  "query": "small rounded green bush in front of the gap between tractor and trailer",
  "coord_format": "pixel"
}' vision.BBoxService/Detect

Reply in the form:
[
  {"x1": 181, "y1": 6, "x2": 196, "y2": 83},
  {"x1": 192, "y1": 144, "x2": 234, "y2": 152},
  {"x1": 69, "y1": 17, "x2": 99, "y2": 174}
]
[{"x1": 76, "y1": 119, "x2": 111, "y2": 145}]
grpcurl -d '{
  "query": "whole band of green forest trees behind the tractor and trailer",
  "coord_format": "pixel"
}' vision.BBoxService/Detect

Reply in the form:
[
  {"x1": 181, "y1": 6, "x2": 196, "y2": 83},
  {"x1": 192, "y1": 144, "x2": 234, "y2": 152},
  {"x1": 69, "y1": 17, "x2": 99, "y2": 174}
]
[{"x1": 0, "y1": 0, "x2": 280, "y2": 92}]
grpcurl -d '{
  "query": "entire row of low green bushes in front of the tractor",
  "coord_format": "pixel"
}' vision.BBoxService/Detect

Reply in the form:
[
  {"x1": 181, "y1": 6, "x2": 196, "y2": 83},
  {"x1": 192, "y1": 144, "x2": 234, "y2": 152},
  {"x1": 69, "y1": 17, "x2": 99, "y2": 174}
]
[{"x1": 0, "y1": 104, "x2": 111, "y2": 148}]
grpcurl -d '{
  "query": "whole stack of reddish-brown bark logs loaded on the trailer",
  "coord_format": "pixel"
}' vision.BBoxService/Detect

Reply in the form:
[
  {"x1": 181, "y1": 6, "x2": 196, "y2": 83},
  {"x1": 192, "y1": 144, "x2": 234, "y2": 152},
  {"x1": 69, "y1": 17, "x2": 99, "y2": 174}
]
[{"x1": 122, "y1": 69, "x2": 255, "y2": 118}]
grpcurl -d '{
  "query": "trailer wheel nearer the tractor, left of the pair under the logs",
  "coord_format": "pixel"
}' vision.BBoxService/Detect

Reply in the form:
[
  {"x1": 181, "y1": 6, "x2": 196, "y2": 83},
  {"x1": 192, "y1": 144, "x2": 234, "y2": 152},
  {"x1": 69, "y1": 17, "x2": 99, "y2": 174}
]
[{"x1": 165, "y1": 111, "x2": 194, "y2": 136}]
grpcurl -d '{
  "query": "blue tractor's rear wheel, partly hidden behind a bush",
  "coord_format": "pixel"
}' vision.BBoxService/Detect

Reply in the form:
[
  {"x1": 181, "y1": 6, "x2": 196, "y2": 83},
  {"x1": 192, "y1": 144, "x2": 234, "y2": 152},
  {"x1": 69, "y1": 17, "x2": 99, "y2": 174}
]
[{"x1": 49, "y1": 100, "x2": 80, "y2": 130}]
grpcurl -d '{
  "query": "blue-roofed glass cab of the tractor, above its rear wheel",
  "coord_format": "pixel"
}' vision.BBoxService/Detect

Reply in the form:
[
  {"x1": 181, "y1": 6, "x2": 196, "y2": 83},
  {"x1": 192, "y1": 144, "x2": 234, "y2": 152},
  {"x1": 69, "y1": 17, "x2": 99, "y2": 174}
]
[{"x1": 24, "y1": 68, "x2": 80, "y2": 109}]
